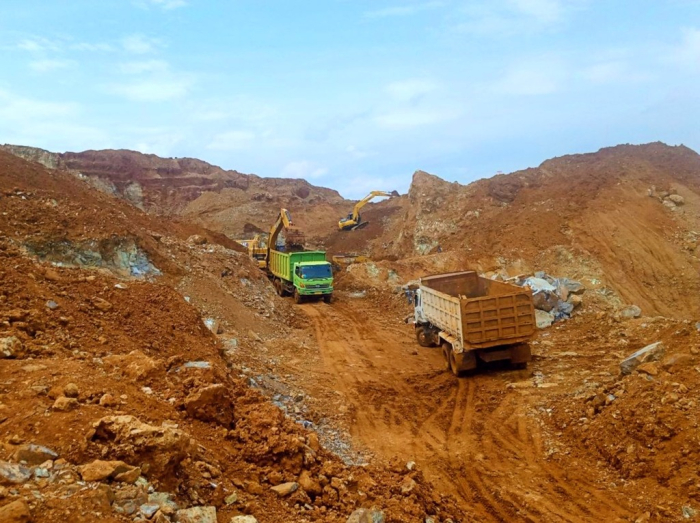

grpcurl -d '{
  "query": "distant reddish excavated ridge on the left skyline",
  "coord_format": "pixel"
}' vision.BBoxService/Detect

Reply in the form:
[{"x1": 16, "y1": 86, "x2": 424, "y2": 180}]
[{"x1": 0, "y1": 145, "x2": 343, "y2": 220}]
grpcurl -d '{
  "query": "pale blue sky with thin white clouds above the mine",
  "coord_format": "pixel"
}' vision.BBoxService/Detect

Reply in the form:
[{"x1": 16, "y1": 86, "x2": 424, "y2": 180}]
[{"x1": 0, "y1": 0, "x2": 700, "y2": 198}]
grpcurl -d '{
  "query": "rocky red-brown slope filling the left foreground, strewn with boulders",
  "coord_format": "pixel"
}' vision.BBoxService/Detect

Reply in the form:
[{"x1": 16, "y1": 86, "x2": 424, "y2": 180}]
[{"x1": 0, "y1": 151, "x2": 457, "y2": 523}]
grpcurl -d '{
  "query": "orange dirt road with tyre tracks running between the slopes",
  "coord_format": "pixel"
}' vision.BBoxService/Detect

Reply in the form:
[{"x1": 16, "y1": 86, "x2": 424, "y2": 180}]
[{"x1": 302, "y1": 303, "x2": 634, "y2": 522}]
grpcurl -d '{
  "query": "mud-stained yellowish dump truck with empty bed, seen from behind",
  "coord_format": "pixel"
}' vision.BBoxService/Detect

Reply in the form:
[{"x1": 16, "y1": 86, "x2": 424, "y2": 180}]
[{"x1": 413, "y1": 271, "x2": 536, "y2": 376}]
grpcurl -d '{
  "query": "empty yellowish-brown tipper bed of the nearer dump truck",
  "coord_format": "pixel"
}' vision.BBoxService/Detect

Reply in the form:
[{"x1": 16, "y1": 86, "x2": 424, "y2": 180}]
[{"x1": 420, "y1": 271, "x2": 536, "y2": 350}]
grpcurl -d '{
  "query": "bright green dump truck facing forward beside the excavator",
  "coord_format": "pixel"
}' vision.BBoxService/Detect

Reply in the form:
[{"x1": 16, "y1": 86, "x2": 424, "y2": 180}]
[{"x1": 267, "y1": 249, "x2": 333, "y2": 303}]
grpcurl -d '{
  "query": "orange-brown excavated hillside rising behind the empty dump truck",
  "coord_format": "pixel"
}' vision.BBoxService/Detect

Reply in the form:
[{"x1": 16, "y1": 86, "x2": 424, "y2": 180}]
[{"x1": 372, "y1": 143, "x2": 700, "y2": 318}]
